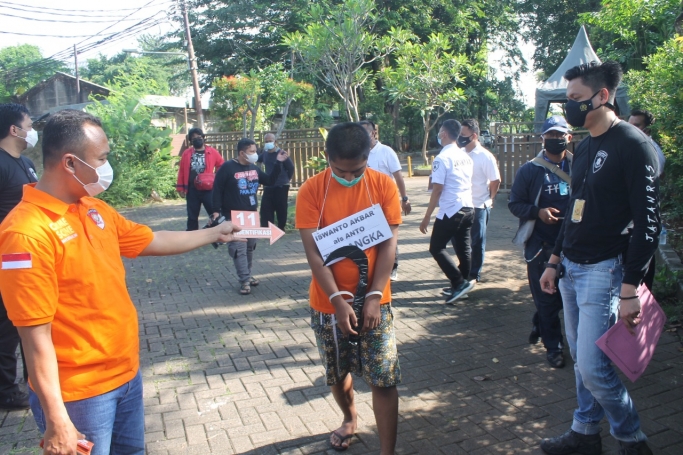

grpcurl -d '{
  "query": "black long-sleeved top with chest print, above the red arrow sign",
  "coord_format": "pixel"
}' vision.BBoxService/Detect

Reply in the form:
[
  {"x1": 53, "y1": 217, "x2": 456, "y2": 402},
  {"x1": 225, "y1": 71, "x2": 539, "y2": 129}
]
[{"x1": 213, "y1": 159, "x2": 282, "y2": 219}]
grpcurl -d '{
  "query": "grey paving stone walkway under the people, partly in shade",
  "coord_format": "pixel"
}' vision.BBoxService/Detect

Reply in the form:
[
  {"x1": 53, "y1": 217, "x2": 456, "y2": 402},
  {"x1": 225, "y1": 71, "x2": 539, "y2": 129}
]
[{"x1": 0, "y1": 178, "x2": 683, "y2": 455}]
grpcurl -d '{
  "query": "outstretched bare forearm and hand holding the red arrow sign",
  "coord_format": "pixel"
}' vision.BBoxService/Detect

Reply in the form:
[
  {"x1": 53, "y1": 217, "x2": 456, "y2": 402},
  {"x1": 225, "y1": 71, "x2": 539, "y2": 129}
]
[{"x1": 140, "y1": 221, "x2": 243, "y2": 256}]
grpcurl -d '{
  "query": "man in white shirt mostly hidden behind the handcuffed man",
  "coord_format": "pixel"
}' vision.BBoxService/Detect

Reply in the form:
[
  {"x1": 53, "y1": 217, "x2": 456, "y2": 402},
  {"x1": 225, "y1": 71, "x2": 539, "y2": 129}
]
[{"x1": 358, "y1": 120, "x2": 411, "y2": 281}]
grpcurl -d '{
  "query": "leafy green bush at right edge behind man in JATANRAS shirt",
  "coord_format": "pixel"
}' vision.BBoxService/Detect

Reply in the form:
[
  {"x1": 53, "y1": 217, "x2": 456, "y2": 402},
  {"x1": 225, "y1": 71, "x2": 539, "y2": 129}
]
[{"x1": 626, "y1": 36, "x2": 683, "y2": 219}]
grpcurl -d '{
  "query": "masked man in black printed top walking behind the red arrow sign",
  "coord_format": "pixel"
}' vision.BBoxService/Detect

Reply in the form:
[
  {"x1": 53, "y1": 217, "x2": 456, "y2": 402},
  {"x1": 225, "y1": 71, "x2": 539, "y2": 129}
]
[{"x1": 212, "y1": 138, "x2": 289, "y2": 295}]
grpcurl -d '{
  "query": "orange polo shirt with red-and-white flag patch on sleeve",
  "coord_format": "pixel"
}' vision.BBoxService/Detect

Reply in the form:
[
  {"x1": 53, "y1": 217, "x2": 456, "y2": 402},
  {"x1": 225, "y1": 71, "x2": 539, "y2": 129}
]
[{"x1": 0, "y1": 185, "x2": 154, "y2": 401}]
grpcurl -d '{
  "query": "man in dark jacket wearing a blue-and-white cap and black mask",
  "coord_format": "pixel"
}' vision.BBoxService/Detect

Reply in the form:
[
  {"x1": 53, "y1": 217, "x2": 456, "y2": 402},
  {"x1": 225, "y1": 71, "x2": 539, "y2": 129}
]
[{"x1": 508, "y1": 115, "x2": 572, "y2": 368}]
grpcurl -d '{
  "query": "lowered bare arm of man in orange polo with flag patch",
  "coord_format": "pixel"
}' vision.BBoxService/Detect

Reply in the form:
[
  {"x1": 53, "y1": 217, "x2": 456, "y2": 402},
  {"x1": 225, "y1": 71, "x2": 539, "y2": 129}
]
[{"x1": 18, "y1": 323, "x2": 83, "y2": 455}]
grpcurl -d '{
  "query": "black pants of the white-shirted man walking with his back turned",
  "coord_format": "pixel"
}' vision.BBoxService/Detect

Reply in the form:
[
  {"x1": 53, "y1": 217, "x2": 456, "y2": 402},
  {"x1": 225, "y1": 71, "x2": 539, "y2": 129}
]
[{"x1": 429, "y1": 207, "x2": 474, "y2": 288}]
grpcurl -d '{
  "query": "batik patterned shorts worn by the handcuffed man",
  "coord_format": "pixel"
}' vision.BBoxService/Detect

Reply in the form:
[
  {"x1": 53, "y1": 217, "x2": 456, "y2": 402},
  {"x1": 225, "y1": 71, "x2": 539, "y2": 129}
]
[{"x1": 311, "y1": 304, "x2": 401, "y2": 387}]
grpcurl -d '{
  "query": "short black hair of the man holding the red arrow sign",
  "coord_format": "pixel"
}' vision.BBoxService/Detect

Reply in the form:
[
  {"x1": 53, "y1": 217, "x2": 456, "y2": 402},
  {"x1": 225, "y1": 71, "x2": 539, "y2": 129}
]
[{"x1": 43, "y1": 109, "x2": 102, "y2": 168}]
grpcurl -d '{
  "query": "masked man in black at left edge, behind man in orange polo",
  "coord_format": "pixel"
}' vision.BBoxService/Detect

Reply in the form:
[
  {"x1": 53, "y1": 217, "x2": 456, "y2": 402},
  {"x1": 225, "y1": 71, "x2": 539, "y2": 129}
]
[{"x1": 0, "y1": 103, "x2": 38, "y2": 410}]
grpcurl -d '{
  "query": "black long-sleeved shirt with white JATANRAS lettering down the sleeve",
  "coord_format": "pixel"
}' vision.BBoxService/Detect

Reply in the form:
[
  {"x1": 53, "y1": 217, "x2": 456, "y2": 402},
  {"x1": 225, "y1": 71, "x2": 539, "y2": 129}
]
[{"x1": 555, "y1": 122, "x2": 660, "y2": 286}]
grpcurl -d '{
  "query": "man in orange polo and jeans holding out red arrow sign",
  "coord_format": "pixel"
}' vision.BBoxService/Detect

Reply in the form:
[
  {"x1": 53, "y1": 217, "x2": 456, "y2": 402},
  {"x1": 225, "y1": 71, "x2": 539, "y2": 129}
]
[{"x1": 0, "y1": 110, "x2": 243, "y2": 455}]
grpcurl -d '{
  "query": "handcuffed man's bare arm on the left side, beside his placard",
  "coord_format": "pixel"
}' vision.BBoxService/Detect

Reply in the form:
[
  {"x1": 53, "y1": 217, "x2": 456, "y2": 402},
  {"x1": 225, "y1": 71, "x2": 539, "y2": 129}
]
[{"x1": 299, "y1": 229, "x2": 360, "y2": 335}]
